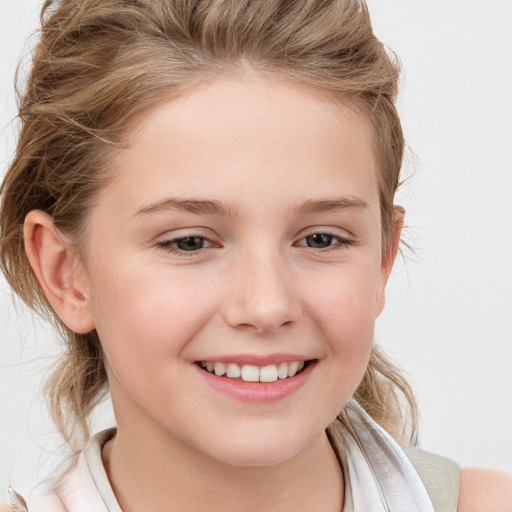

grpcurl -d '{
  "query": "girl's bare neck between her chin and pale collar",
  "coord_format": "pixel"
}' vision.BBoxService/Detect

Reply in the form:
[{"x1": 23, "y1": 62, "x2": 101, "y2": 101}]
[{"x1": 102, "y1": 427, "x2": 344, "y2": 512}]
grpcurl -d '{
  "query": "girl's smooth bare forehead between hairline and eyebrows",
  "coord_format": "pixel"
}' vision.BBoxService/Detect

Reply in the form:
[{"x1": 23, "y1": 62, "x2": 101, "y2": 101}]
[{"x1": 102, "y1": 77, "x2": 378, "y2": 217}]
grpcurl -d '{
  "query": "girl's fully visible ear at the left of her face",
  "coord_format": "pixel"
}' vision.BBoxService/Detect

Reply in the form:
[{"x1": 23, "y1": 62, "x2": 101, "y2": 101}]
[{"x1": 23, "y1": 210, "x2": 95, "y2": 334}]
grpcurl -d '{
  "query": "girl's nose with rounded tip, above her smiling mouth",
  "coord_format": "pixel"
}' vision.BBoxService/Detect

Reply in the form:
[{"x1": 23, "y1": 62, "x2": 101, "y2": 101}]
[{"x1": 225, "y1": 251, "x2": 301, "y2": 334}]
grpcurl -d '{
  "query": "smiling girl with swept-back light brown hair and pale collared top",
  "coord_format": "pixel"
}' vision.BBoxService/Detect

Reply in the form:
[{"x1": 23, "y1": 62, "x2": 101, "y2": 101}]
[{"x1": 0, "y1": 0, "x2": 512, "y2": 512}]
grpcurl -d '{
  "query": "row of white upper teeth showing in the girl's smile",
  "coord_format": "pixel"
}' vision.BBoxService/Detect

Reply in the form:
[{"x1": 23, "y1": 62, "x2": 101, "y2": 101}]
[{"x1": 201, "y1": 361, "x2": 304, "y2": 382}]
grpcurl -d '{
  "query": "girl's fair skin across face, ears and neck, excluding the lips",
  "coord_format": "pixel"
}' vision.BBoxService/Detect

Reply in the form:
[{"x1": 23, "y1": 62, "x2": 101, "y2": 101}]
[{"x1": 25, "y1": 76, "x2": 512, "y2": 512}]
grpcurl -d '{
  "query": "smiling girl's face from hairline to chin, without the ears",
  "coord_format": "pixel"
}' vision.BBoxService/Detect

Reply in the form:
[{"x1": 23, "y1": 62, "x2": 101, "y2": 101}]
[{"x1": 78, "y1": 78, "x2": 396, "y2": 465}]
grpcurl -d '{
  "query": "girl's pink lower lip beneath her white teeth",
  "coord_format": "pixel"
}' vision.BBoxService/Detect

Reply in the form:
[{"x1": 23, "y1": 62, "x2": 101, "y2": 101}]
[{"x1": 194, "y1": 361, "x2": 316, "y2": 404}]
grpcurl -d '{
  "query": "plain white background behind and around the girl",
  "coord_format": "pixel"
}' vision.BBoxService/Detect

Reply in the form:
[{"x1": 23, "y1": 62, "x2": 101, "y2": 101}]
[{"x1": 0, "y1": 0, "x2": 512, "y2": 499}]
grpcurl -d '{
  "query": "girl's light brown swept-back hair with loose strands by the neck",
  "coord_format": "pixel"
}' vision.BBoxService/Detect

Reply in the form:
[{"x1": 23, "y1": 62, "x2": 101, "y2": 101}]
[{"x1": 0, "y1": 0, "x2": 417, "y2": 449}]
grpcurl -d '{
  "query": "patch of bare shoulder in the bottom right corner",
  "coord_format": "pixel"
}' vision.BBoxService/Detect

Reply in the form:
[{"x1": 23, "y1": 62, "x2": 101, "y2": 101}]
[{"x1": 457, "y1": 468, "x2": 512, "y2": 512}]
